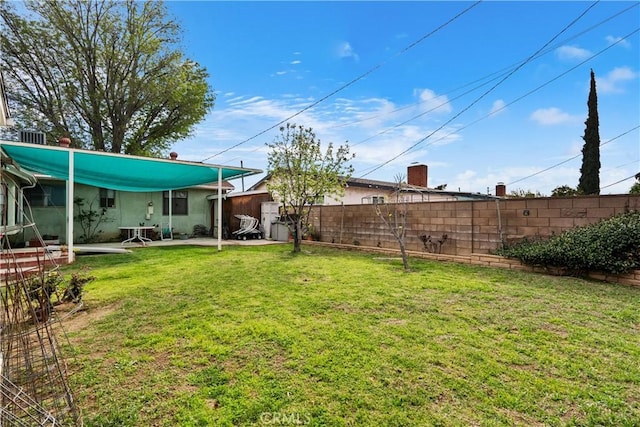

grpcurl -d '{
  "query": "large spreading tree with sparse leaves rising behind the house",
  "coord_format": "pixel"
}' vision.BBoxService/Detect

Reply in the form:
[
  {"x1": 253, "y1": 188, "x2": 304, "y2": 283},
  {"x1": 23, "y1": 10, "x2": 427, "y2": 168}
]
[{"x1": 0, "y1": 0, "x2": 214, "y2": 155}]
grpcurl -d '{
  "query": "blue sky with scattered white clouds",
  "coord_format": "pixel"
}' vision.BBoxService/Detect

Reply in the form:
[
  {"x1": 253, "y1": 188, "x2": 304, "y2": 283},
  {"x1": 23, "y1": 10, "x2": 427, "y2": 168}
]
[{"x1": 166, "y1": 1, "x2": 640, "y2": 195}]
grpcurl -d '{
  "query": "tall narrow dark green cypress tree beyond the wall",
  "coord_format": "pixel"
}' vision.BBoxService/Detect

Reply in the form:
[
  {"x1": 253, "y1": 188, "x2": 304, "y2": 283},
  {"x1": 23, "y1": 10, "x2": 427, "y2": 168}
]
[{"x1": 578, "y1": 70, "x2": 600, "y2": 194}]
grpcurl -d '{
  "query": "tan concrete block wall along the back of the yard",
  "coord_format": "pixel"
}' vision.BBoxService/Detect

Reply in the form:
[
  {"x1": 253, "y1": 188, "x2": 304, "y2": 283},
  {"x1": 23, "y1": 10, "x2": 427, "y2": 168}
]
[{"x1": 310, "y1": 194, "x2": 640, "y2": 255}]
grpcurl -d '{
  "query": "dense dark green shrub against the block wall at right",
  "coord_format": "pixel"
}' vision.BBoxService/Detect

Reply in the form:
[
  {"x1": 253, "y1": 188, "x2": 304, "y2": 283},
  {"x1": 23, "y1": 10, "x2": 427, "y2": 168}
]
[{"x1": 496, "y1": 211, "x2": 640, "y2": 274}]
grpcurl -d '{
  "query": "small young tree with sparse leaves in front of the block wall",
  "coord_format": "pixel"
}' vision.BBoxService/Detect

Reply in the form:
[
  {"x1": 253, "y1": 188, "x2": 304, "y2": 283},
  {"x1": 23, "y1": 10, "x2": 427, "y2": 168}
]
[{"x1": 267, "y1": 123, "x2": 354, "y2": 252}]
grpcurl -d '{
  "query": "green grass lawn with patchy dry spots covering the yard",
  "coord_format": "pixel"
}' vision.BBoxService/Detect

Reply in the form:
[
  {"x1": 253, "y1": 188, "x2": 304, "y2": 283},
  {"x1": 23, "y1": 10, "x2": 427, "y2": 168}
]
[{"x1": 57, "y1": 245, "x2": 640, "y2": 426}]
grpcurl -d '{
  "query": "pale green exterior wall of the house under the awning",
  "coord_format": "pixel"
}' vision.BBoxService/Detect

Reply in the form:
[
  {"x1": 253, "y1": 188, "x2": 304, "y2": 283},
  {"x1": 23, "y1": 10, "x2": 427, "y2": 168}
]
[{"x1": 25, "y1": 180, "x2": 212, "y2": 243}]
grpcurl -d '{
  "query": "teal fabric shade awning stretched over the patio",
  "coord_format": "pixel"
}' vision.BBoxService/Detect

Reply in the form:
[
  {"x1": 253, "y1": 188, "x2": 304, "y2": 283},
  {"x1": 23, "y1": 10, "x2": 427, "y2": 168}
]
[{"x1": 0, "y1": 141, "x2": 262, "y2": 192}]
